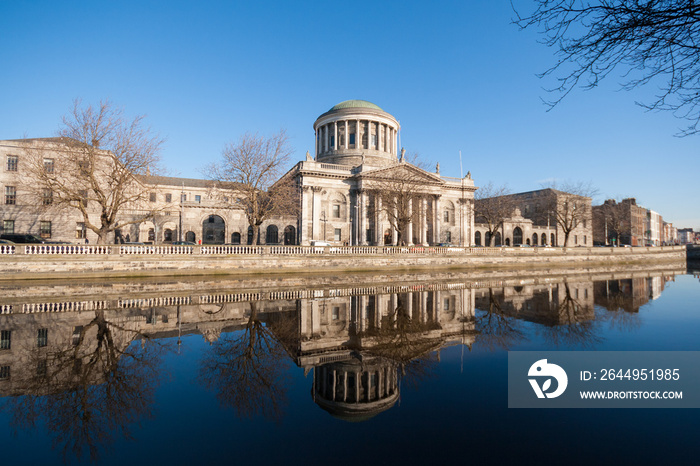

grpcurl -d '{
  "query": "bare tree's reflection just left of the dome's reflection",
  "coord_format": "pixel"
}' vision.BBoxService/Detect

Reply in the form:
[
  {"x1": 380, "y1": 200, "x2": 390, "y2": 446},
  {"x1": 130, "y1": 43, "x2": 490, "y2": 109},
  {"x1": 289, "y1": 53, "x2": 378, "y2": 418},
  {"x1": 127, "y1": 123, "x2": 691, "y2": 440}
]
[{"x1": 199, "y1": 301, "x2": 295, "y2": 420}]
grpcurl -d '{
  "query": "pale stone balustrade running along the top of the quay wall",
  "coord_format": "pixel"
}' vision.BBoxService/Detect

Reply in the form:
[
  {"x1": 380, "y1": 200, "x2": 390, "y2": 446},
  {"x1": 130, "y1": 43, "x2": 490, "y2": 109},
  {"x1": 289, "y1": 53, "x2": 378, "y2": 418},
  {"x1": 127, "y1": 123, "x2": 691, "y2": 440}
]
[{"x1": 0, "y1": 244, "x2": 683, "y2": 256}]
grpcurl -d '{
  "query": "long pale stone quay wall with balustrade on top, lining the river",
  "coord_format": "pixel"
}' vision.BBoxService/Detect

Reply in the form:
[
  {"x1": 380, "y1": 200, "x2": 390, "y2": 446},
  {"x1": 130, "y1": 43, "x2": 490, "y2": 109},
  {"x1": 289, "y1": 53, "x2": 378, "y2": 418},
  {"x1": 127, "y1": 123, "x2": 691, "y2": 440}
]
[{"x1": 0, "y1": 245, "x2": 686, "y2": 281}]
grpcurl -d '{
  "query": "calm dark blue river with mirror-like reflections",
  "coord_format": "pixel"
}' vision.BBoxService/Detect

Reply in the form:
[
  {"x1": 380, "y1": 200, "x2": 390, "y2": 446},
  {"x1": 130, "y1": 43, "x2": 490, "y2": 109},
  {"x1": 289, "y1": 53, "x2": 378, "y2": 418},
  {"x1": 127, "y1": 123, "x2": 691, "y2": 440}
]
[{"x1": 0, "y1": 264, "x2": 700, "y2": 465}]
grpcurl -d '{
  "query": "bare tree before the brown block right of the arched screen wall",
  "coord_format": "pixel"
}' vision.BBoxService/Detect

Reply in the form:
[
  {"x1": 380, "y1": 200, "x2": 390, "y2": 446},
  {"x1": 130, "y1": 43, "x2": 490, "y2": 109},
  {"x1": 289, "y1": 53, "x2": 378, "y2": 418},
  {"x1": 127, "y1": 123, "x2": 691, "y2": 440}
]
[{"x1": 535, "y1": 182, "x2": 597, "y2": 247}]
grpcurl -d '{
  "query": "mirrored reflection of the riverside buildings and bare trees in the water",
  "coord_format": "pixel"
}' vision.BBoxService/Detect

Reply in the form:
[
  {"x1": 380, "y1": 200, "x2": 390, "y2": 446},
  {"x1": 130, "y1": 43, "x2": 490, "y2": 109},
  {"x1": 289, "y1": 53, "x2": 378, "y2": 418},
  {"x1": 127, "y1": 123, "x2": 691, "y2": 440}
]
[{"x1": 0, "y1": 271, "x2": 677, "y2": 457}]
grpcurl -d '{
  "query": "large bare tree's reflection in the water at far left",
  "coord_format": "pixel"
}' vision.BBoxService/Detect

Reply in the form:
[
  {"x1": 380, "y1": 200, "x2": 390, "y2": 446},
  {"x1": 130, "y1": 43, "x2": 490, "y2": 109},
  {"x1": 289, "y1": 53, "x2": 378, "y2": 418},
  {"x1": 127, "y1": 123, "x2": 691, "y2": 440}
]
[{"x1": 0, "y1": 310, "x2": 162, "y2": 461}]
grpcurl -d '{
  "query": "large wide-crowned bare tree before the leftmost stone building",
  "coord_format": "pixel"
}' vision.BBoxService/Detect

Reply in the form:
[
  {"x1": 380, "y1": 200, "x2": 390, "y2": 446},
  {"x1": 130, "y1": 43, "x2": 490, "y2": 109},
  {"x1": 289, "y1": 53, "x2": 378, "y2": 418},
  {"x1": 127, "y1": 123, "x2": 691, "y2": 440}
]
[{"x1": 22, "y1": 100, "x2": 163, "y2": 244}]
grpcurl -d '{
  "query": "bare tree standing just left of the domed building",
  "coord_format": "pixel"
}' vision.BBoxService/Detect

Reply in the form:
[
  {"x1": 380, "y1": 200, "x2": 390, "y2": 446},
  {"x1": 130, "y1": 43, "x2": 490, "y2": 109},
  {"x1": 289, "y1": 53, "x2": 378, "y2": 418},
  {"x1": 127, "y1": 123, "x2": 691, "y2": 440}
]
[{"x1": 205, "y1": 130, "x2": 299, "y2": 244}]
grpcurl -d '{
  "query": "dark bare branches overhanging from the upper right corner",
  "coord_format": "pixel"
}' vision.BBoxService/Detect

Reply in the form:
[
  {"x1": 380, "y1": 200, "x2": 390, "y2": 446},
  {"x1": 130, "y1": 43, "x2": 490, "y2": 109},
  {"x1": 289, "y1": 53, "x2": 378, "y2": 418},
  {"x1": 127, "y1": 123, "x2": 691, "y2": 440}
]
[{"x1": 515, "y1": 0, "x2": 700, "y2": 135}]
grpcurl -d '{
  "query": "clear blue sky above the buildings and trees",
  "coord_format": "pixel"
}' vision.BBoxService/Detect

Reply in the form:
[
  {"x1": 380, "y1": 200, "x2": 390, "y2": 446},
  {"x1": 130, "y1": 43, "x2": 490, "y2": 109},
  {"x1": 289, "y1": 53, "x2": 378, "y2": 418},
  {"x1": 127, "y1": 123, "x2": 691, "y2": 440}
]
[{"x1": 0, "y1": 0, "x2": 700, "y2": 230}]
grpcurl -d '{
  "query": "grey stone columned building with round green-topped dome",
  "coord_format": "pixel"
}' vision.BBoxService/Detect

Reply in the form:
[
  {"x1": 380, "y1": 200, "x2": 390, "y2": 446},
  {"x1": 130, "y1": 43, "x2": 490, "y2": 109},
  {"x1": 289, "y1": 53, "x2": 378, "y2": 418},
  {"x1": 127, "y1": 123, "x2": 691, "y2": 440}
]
[{"x1": 285, "y1": 100, "x2": 476, "y2": 246}]
